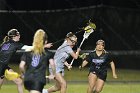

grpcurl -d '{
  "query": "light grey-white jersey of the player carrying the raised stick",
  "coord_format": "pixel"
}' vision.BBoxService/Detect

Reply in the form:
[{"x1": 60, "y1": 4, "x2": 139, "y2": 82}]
[{"x1": 54, "y1": 41, "x2": 74, "y2": 68}]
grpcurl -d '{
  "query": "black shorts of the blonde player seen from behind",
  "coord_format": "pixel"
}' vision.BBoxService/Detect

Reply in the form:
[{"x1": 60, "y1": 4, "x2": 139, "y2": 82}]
[{"x1": 24, "y1": 80, "x2": 46, "y2": 93}]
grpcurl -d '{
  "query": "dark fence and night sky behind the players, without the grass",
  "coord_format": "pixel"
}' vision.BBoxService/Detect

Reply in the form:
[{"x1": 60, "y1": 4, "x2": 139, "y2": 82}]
[{"x1": 0, "y1": 0, "x2": 140, "y2": 69}]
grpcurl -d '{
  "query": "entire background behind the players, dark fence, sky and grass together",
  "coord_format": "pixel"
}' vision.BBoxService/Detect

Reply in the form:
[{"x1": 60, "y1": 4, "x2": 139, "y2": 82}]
[{"x1": 0, "y1": 0, "x2": 140, "y2": 93}]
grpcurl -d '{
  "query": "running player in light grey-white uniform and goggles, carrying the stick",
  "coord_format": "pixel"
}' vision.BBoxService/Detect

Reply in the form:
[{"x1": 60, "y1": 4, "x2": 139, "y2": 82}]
[{"x1": 43, "y1": 32, "x2": 80, "y2": 93}]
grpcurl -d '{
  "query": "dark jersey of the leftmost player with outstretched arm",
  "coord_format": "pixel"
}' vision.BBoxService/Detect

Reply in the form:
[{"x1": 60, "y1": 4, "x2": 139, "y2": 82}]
[{"x1": 0, "y1": 40, "x2": 23, "y2": 65}]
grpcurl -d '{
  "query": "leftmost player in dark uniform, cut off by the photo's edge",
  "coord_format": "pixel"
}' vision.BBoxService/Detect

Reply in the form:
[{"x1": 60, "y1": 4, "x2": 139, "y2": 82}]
[{"x1": 0, "y1": 29, "x2": 23, "y2": 93}]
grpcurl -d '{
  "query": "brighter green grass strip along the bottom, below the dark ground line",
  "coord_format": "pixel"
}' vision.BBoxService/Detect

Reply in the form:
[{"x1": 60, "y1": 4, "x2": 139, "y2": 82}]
[{"x1": 0, "y1": 83, "x2": 140, "y2": 93}]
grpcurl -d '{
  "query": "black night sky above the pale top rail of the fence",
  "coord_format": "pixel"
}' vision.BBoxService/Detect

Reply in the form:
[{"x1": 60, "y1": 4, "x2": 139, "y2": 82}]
[{"x1": 0, "y1": 0, "x2": 140, "y2": 10}]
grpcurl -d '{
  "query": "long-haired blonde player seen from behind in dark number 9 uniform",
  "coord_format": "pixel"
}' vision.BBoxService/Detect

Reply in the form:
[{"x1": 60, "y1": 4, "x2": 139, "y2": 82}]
[{"x1": 19, "y1": 29, "x2": 55, "y2": 93}]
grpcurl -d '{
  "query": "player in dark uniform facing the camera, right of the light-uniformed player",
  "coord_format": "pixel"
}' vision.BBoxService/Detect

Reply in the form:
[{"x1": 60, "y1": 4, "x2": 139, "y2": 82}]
[{"x1": 80, "y1": 40, "x2": 117, "y2": 93}]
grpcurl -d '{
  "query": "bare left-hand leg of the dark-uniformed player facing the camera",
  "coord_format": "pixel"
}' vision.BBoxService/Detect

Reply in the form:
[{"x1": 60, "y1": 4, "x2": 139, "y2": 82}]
[{"x1": 87, "y1": 72, "x2": 97, "y2": 93}]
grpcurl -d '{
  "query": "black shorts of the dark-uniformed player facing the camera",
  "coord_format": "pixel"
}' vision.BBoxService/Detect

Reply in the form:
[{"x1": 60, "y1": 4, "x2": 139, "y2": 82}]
[{"x1": 89, "y1": 69, "x2": 107, "y2": 81}]
